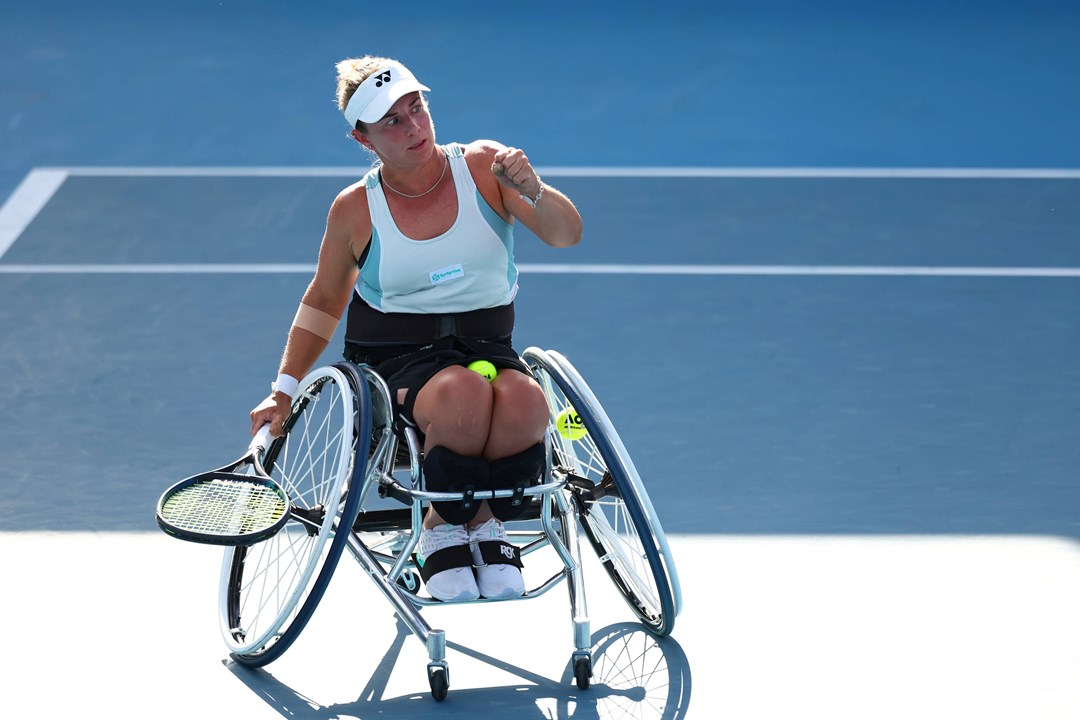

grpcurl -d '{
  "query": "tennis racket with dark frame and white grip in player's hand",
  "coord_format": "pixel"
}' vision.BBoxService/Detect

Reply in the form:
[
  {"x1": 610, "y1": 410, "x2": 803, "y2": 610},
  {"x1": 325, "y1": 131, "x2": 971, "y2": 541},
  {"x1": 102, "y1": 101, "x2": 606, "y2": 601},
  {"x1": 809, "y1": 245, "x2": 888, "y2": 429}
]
[{"x1": 158, "y1": 425, "x2": 292, "y2": 545}]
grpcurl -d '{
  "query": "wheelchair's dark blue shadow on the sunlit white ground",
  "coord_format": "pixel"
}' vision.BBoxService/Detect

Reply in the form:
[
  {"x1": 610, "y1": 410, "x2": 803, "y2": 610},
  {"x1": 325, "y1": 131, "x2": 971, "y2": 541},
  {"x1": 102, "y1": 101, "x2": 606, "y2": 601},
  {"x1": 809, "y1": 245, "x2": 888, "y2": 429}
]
[{"x1": 225, "y1": 621, "x2": 691, "y2": 720}]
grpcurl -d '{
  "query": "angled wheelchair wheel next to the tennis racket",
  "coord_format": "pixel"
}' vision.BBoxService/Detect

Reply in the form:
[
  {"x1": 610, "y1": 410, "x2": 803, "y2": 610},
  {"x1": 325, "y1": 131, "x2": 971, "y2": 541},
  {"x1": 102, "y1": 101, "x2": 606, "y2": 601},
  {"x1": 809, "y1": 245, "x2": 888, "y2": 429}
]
[{"x1": 219, "y1": 363, "x2": 370, "y2": 667}]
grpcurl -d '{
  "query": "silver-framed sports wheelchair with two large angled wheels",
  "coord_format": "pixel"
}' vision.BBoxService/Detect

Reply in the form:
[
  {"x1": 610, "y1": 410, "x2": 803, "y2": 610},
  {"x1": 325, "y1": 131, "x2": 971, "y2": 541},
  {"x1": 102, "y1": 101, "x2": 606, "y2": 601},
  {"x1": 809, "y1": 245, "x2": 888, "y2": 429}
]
[{"x1": 219, "y1": 348, "x2": 681, "y2": 701}]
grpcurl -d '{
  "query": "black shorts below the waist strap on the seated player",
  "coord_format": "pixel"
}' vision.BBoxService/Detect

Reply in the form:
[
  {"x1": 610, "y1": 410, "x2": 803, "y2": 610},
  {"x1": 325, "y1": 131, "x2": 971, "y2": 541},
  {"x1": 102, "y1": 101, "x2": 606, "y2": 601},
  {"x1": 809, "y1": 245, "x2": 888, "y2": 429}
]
[{"x1": 345, "y1": 336, "x2": 531, "y2": 436}]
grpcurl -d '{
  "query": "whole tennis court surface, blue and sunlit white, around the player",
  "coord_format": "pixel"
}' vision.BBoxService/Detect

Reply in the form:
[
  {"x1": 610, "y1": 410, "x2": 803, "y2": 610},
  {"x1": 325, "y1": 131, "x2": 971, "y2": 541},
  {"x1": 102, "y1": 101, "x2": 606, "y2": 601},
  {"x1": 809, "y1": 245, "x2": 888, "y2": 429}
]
[{"x1": 0, "y1": 1, "x2": 1080, "y2": 718}]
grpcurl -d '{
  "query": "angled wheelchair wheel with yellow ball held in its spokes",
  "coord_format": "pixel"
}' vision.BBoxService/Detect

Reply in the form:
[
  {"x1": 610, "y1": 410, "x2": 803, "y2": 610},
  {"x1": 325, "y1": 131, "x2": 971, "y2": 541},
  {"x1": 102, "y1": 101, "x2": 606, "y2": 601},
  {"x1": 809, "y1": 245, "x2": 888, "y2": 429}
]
[{"x1": 523, "y1": 348, "x2": 681, "y2": 637}]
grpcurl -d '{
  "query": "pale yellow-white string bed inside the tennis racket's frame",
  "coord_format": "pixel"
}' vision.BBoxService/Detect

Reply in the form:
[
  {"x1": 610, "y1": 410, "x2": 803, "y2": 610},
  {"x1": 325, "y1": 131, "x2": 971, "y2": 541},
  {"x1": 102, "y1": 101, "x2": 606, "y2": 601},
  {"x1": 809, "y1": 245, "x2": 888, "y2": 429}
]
[{"x1": 161, "y1": 478, "x2": 287, "y2": 535}]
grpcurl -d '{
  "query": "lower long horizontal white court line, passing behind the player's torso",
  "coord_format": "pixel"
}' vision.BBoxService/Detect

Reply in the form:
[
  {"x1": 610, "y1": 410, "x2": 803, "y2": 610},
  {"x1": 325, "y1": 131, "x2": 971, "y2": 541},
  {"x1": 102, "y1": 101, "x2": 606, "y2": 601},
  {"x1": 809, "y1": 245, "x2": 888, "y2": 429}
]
[{"x1": 0, "y1": 262, "x2": 1080, "y2": 277}]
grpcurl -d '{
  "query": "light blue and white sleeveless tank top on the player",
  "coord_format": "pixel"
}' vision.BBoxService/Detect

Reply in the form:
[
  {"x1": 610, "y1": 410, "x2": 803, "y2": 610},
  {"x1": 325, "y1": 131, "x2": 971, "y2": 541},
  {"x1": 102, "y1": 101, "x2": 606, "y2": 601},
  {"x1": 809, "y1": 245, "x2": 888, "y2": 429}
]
[{"x1": 356, "y1": 144, "x2": 517, "y2": 313}]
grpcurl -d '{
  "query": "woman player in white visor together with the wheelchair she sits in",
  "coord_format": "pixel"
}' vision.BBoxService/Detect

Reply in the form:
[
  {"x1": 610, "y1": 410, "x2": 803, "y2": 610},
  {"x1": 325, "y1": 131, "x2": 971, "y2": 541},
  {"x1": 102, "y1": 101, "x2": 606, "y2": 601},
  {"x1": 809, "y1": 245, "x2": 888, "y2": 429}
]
[{"x1": 221, "y1": 57, "x2": 679, "y2": 698}]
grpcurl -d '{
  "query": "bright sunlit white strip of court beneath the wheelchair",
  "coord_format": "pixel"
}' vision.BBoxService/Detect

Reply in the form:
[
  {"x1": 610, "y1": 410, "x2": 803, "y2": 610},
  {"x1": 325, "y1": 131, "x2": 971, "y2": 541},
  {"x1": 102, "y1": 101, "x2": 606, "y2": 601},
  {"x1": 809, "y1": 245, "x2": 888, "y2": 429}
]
[{"x1": 6, "y1": 533, "x2": 1080, "y2": 720}]
